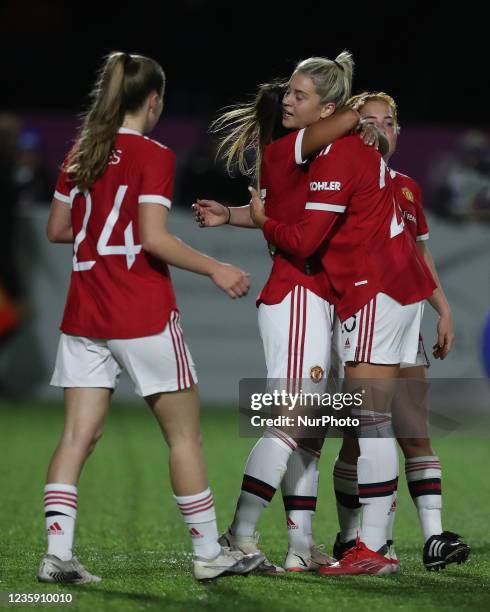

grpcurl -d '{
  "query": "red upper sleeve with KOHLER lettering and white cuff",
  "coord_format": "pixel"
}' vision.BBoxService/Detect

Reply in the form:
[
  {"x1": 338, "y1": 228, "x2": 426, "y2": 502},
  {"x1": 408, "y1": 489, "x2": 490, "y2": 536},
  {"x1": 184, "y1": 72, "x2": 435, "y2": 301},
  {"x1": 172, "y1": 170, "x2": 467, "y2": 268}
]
[{"x1": 305, "y1": 144, "x2": 357, "y2": 213}]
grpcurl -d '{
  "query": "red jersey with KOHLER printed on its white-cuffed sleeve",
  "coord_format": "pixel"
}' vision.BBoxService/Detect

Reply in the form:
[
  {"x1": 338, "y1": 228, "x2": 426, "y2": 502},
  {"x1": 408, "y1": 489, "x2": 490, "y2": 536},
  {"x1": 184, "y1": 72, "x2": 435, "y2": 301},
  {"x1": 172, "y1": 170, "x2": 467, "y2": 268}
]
[{"x1": 264, "y1": 136, "x2": 435, "y2": 321}]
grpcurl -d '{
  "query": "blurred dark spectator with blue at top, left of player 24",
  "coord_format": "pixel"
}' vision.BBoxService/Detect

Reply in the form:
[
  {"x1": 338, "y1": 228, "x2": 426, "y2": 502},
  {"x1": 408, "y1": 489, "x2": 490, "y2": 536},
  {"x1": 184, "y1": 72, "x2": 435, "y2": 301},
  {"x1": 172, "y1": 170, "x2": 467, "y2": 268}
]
[{"x1": 15, "y1": 130, "x2": 52, "y2": 207}]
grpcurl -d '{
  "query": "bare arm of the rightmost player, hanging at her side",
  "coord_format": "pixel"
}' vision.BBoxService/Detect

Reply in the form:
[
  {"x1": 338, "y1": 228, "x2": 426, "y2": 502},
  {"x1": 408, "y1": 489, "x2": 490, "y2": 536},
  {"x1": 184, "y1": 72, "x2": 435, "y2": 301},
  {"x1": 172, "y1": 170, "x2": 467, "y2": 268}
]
[{"x1": 417, "y1": 240, "x2": 454, "y2": 359}]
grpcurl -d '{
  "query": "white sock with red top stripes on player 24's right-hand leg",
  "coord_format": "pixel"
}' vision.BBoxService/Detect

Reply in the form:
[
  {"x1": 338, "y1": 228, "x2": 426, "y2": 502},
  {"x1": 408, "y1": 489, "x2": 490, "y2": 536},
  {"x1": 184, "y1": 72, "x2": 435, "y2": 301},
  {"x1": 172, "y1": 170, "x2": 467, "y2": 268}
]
[{"x1": 174, "y1": 488, "x2": 221, "y2": 559}]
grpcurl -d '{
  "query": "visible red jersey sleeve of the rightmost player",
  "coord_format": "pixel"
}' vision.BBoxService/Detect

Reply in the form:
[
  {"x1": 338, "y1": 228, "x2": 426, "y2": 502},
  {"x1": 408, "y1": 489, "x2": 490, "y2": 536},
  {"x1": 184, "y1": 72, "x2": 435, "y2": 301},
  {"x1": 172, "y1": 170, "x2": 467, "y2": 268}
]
[{"x1": 390, "y1": 170, "x2": 429, "y2": 241}]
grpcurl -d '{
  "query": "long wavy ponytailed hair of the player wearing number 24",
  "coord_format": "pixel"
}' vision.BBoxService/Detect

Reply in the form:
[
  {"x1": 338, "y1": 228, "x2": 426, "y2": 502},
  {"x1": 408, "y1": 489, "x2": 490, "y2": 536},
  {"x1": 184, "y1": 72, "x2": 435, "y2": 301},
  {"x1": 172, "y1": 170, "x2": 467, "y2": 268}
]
[{"x1": 65, "y1": 51, "x2": 165, "y2": 190}]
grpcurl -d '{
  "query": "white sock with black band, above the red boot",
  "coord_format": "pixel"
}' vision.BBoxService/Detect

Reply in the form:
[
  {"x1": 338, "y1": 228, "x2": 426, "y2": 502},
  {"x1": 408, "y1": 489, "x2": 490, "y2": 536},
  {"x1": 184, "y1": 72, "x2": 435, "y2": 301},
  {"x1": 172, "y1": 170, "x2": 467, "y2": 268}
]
[{"x1": 357, "y1": 437, "x2": 398, "y2": 551}]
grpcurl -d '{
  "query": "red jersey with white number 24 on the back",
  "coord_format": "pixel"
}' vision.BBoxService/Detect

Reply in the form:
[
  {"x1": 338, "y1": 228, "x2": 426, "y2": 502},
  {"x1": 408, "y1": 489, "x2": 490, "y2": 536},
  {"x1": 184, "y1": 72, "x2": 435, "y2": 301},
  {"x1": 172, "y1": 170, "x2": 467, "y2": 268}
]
[{"x1": 54, "y1": 128, "x2": 176, "y2": 338}]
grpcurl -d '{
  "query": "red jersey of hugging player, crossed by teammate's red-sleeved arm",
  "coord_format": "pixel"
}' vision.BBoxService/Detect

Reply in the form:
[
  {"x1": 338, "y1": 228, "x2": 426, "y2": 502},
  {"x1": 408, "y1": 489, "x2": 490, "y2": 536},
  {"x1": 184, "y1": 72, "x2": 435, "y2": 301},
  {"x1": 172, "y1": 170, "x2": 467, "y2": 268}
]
[{"x1": 257, "y1": 130, "x2": 333, "y2": 305}]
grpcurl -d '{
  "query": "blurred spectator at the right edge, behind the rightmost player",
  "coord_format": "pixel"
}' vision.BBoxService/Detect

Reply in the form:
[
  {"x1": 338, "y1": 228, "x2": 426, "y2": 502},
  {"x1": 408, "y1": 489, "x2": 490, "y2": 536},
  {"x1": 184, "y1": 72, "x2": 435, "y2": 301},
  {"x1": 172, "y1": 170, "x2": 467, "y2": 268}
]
[{"x1": 430, "y1": 131, "x2": 490, "y2": 220}]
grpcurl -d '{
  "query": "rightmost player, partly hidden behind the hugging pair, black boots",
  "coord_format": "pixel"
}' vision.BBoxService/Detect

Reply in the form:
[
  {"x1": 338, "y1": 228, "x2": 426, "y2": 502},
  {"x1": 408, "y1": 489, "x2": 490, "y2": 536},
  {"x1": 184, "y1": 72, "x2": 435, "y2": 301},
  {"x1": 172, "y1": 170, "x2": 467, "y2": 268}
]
[{"x1": 334, "y1": 92, "x2": 469, "y2": 569}]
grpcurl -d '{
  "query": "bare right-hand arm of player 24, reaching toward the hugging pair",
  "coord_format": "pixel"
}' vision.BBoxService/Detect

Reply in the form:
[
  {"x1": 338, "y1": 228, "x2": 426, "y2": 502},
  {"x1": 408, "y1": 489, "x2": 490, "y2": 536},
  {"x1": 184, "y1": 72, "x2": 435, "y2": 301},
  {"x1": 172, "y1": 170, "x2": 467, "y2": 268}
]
[{"x1": 139, "y1": 202, "x2": 250, "y2": 298}]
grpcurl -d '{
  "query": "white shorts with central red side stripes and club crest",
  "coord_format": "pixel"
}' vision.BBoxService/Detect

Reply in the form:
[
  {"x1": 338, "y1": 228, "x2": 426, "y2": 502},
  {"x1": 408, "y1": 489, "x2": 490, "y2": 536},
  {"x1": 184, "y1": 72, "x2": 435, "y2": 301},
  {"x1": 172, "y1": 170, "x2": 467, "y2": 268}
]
[{"x1": 258, "y1": 286, "x2": 334, "y2": 393}]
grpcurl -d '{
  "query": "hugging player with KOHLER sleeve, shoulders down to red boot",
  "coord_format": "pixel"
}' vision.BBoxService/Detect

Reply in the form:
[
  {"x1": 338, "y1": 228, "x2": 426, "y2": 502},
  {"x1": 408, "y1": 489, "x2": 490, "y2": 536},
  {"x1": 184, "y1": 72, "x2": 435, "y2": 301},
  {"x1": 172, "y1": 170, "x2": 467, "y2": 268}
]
[{"x1": 251, "y1": 83, "x2": 435, "y2": 575}]
